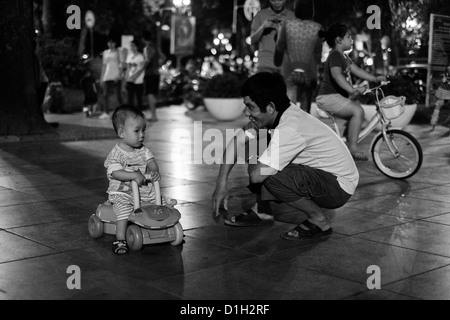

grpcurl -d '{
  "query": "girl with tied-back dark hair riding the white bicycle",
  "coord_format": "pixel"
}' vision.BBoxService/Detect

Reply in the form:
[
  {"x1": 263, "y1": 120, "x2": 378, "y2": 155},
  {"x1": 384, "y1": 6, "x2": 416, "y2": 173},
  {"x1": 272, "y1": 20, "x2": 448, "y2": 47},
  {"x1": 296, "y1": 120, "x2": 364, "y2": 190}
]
[{"x1": 316, "y1": 24, "x2": 386, "y2": 161}]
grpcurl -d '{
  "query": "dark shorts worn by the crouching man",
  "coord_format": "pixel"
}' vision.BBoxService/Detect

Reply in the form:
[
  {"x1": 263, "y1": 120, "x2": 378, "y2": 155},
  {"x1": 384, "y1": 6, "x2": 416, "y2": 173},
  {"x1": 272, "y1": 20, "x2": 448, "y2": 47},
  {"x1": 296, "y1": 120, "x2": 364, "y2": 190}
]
[{"x1": 249, "y1": 164, "x2": 351, "y2": 209}]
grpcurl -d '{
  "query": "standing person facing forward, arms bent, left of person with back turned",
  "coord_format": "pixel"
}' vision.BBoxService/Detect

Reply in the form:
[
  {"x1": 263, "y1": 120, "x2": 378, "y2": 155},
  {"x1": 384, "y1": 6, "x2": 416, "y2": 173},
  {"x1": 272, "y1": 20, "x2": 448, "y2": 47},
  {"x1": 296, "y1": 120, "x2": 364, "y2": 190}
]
[{"x1": 250, "y1": 0, "x2": 295, "y2": 73}]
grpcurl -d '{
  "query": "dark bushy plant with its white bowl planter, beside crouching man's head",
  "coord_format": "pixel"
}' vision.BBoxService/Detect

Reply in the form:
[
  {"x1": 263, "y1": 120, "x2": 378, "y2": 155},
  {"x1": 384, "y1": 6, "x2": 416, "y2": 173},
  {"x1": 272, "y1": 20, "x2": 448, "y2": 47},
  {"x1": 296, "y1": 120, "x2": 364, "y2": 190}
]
[{"x1": 202, "y1": 72, "x2": 245, "y2": 121}]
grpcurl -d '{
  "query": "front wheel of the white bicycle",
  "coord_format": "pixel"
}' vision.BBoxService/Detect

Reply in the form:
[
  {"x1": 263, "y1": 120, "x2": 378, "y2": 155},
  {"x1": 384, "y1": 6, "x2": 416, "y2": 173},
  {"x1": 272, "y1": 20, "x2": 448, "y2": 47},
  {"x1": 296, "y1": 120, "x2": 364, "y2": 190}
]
[{"x1": 371, "y1": 130, "x2": 423, "y2": 179}]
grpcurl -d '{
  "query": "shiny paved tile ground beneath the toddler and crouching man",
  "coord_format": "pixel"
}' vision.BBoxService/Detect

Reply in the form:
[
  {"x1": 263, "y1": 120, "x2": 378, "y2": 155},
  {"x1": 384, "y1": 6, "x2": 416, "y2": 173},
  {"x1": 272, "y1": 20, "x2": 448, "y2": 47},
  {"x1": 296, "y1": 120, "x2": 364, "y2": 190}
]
[{"x1": 0, "y1": 106, "x2": 450, "y2": 300}]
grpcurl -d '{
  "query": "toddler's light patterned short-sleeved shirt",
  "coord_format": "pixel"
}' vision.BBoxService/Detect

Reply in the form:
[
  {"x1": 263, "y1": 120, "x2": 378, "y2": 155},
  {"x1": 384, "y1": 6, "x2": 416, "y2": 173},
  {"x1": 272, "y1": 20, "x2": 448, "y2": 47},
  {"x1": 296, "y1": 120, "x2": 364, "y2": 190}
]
[{"x1": 105, "y1": 144, "x2": 155, "y2": 201}]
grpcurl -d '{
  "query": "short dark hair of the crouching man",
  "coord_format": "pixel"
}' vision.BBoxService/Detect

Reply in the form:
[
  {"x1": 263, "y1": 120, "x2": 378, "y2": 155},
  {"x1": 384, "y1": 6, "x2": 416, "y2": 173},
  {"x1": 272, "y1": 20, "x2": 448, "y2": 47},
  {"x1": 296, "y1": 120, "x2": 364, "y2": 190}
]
[{"x1": 241, "y1": 72, "x2": 291, "y2": 112}]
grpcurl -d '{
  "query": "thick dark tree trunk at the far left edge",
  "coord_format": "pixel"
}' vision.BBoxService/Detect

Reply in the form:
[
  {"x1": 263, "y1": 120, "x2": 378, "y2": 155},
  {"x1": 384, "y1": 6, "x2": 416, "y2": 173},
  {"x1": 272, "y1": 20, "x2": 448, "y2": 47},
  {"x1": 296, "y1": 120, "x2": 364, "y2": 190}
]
[{"x1": 0, "y1": 0, "x2": 54, "y2": 136}]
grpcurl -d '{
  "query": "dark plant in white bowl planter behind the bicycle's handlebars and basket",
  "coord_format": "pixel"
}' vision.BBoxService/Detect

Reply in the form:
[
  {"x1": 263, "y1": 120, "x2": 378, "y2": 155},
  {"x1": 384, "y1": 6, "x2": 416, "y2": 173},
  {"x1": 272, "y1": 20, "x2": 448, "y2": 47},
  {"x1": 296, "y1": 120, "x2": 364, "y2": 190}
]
[{"x1": 358, "y1": 76, "x2": 420, "y2": 128}]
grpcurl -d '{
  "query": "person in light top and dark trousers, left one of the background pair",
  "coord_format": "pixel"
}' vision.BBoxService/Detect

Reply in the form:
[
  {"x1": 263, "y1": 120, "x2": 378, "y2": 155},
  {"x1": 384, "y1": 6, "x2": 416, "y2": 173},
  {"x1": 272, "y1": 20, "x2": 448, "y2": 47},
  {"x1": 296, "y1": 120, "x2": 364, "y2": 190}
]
[{"x1": 99, "y1": 38, "x2": 123, "y2": 120}]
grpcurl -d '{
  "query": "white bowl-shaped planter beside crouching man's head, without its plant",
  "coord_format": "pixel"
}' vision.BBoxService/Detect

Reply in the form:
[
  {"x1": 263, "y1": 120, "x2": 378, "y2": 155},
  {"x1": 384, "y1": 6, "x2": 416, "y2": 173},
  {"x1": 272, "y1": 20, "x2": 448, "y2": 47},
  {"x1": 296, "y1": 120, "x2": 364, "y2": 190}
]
[{"x1": 204, "y1": 98, "x2": 245, "y2": 121}]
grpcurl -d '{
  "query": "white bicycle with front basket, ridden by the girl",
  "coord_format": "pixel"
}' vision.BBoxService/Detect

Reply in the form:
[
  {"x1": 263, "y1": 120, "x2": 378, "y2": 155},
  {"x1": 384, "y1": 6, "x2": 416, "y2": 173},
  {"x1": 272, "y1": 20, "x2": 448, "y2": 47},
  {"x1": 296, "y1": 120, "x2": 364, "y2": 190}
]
[{"x1": 317, "y1": 82, "x2": 423, "y2": 179}]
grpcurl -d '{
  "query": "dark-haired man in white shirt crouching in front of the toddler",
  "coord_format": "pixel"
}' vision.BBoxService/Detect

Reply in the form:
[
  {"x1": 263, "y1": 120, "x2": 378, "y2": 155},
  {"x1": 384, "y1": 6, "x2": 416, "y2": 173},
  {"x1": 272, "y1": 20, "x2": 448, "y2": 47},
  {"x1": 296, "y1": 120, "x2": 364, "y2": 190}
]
[{"x1": 212, "y1": 72, "x2": 359, "y2": 240}]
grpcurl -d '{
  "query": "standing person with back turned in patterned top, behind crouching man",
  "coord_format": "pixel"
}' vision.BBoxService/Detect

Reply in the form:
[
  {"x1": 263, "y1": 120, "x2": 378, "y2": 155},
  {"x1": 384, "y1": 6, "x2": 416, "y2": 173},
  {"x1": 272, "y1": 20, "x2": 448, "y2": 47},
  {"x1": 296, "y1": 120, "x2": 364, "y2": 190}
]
[{"x1": 274, "y1": 0, "x2": 323, "y2": 113}]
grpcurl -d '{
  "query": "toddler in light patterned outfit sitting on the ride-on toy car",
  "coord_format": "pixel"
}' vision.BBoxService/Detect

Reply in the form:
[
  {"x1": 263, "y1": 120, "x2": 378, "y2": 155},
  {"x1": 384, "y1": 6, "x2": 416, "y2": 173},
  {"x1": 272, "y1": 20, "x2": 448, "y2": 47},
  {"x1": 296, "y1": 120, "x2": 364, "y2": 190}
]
[{"x1": 105, "y1": 105, "x2": 161, "y2": 254}]
